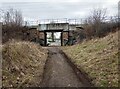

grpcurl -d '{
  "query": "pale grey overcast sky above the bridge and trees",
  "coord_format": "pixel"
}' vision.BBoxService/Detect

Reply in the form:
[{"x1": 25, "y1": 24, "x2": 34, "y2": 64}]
[{"x1": 0, "y1": 0, "x2": 119, "y2": 20}]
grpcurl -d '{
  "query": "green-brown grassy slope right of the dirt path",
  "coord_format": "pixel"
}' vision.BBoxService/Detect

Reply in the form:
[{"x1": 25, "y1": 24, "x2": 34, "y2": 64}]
[{"x1": 62, "y1": 32, "x2": 119, "y2": 87}]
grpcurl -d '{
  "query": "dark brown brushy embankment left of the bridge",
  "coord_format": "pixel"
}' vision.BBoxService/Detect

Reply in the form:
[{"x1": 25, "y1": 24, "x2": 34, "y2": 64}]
[{"x1": 2, "y1": 25, "x2": 38, "y2": 44}]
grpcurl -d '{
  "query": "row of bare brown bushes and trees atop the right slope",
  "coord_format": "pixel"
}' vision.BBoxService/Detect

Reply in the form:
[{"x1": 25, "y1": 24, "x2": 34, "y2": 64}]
[{"x1": 72, "y1": 9, "x2": 120, "y2": 41}]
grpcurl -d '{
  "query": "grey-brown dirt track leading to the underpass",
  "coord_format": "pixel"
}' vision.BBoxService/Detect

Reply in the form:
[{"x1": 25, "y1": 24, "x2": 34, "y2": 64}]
[{"x1": 41, "y1": 47, "x2": 92, "y2": 87}]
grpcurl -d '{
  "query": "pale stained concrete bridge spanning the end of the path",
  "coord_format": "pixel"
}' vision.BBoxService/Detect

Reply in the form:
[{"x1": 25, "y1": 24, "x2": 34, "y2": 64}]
[{"x1": 29, "y1": 20, "x2": 81, "y2": 46}]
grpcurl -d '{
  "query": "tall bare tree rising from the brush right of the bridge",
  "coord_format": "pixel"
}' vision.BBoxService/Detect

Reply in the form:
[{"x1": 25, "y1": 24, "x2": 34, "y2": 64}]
[{"x1": 84, "y1": 9, "x2": 107, "y2": 38}]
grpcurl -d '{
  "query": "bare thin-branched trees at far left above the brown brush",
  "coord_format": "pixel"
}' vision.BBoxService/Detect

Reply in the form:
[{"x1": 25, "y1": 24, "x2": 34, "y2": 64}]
[{"x1": 2, "y1": 8, "x2": 23, "y2": 43}]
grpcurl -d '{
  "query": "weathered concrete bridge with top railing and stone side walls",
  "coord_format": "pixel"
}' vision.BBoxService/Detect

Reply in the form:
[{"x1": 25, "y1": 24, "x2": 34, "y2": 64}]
[{"x1": 31, "y1": 19, "x2": 83, "y2": 46}]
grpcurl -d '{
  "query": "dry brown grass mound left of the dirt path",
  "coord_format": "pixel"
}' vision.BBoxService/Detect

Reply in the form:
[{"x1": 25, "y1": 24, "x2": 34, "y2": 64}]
[{"x1": 2, "y1": 41, "x2": 47, "y2": 88}]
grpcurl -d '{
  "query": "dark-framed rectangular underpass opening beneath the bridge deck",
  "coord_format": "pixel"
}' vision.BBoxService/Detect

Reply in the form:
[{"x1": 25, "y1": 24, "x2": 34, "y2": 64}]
[{"x1": 40, "y1": 29, "x2": 69, "y2": 46}]
